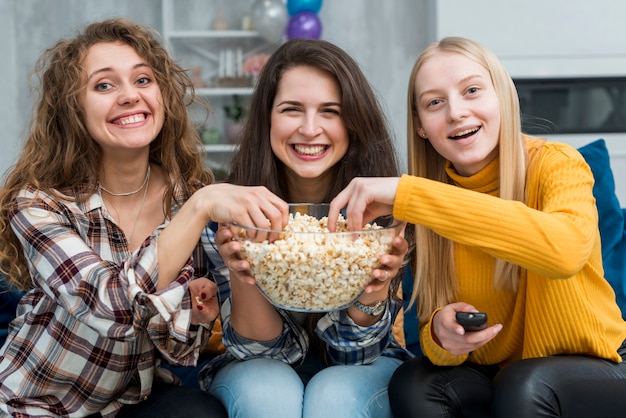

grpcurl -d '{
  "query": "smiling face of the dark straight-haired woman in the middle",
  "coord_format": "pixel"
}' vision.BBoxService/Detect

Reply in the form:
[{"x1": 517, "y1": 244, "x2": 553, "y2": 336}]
[{"x1": 270, "y1": 66, "x2": 349, "y2": 189}]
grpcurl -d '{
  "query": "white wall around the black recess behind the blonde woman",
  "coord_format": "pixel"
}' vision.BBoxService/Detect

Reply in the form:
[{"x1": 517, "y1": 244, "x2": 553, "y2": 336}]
[{"x1": 429, "y1": 0, "x2": 626, "y2": 206}]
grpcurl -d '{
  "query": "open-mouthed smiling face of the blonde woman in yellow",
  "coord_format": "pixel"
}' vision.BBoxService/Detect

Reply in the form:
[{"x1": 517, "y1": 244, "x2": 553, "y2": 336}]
[{"x1": 414, "y1": 52, "x2": 500, "y2": 176}]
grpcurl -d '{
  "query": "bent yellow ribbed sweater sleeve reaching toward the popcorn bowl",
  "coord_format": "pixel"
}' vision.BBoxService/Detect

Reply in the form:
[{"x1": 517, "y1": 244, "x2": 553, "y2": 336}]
[{"x1": 394, "y1": 145, "x2": 598, "y2": 278}]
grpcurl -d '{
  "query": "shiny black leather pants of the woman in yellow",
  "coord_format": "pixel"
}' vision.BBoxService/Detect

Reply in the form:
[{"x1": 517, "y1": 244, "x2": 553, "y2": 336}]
[{"x1": 389, "y1": 342, "x2": 626, "y2": 418}]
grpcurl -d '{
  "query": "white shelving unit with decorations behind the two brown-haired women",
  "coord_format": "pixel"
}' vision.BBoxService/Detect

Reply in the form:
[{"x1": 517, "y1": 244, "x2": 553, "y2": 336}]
[{"x1": 162, "y1": 0, "x2": 277, "y2": 178}]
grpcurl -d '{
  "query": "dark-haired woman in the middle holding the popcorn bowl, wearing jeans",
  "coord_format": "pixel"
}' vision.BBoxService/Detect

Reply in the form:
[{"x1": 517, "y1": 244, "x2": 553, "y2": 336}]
[{"x1": 201, "y1": 39, "x2": 410, "y2": 418}]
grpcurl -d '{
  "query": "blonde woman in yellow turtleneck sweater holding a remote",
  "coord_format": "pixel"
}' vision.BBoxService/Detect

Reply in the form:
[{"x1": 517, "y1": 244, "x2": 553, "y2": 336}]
[{"x1": 329, "y1": 38, "x2": 626, "y2": 418}]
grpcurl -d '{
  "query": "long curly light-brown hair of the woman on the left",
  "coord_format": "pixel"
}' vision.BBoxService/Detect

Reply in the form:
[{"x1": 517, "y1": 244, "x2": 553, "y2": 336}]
[{"x1": 0, "y1": 18, "x2": 214, "y2": 289}]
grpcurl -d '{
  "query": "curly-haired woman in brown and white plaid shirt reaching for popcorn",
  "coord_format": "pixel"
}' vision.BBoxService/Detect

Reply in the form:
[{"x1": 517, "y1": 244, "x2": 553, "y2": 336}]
[{"x1": 0, "y1": 19, "x2": 287, "y2": 418}]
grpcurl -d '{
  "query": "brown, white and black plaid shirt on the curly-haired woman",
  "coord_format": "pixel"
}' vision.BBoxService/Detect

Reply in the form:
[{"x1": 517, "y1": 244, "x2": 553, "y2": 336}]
[{"x1": 0, "y1": 188, "x2": 210, "y2": 417}]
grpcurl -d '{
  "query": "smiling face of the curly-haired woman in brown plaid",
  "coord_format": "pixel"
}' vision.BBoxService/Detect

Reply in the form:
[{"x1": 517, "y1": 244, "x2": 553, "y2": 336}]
[{"x1": 80, "y1": 43, "x2": 164, "y2": 156}]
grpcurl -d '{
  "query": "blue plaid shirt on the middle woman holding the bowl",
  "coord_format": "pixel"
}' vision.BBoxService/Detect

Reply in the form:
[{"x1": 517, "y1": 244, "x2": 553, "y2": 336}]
[{"x1": 199, "y1": 223, "x2": 413, "y2": 390}]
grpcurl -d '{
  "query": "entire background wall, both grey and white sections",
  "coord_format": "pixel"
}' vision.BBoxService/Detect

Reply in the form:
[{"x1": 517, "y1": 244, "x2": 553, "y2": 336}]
[{"x1": 0, "y1": 0, "x2": 626, "y2": 204}]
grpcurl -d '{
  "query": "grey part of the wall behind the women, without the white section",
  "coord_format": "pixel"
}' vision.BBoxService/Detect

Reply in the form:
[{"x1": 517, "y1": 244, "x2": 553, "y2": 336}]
[{"x1": 0, "y1": 0, "x2": 429, "y2": 174}]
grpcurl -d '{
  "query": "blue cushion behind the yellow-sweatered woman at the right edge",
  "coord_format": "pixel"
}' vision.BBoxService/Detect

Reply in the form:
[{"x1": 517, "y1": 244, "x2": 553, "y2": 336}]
[{"x1": 578, "y1": 139, "x2": 626, "y2": 319}]
